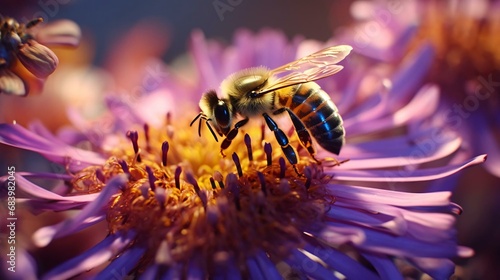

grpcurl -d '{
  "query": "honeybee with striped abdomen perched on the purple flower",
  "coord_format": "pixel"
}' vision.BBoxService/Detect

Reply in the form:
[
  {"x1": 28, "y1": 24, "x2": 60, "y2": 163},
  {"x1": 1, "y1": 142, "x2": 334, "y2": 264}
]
[{"x1": 190, "y1": 45, "x2": 352, "y2": 171}]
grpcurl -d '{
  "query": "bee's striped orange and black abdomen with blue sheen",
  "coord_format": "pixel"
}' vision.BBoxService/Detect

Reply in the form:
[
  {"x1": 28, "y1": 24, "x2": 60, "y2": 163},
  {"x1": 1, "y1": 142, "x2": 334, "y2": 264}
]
[{"x1": 278, "y1": 82, "x2": 345, "y2": 155}]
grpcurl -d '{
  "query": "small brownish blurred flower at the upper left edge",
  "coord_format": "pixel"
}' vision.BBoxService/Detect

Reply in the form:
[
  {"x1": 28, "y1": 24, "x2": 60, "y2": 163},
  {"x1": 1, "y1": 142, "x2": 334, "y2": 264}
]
[{"x1": 0, "y1": 17, "x2": 80, "y2": 96}]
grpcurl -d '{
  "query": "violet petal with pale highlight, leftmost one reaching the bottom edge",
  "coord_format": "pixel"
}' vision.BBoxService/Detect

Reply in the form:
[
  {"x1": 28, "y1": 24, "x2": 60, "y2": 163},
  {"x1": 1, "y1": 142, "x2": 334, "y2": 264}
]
[{"x1": 42, "y1": 232, "x2": 133, "y2": 279}]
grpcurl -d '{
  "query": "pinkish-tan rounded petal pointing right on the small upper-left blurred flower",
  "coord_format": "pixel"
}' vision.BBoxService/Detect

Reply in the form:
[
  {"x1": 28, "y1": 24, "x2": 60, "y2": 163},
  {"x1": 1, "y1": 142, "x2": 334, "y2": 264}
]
[{"x1": 34, "y1": 20, "x2": 82, "y2": 47}]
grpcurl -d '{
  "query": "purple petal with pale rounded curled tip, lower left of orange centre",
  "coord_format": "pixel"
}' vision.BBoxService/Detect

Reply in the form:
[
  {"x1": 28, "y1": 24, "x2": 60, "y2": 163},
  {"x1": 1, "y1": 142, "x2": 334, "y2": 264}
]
[{"x1": 33, "y1": 174, "x2": 128, "y2": 247}]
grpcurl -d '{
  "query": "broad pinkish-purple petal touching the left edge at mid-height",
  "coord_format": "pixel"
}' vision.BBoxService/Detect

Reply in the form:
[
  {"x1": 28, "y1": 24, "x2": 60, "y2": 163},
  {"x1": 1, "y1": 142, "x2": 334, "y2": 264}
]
[{"x1": 0, "y1": 124, "x2": 104, "y2": 171}]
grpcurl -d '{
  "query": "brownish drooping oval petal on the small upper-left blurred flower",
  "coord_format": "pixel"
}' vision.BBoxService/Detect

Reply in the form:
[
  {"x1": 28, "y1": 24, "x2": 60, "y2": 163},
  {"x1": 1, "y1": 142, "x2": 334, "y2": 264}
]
[{"x1": 17, "y1": 40, "x2": 59, "y2": 78}]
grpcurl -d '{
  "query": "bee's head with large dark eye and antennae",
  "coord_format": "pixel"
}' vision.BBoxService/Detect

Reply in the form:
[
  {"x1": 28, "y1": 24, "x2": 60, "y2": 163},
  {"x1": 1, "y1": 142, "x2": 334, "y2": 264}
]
[{"x1": 191, "y1": 90, "x2": 233, "y2": 141}]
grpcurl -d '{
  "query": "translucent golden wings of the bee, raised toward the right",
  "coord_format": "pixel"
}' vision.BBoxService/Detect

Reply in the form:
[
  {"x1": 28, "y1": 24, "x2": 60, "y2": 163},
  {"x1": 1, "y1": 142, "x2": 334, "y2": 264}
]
[{"x1": 257, "y1": 45, "x2": 352, "y2": 94}]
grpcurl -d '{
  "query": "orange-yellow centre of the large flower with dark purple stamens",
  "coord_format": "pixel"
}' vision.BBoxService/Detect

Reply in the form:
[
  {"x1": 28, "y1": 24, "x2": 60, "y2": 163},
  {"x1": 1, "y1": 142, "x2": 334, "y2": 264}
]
[{"x1": 67, "y1": 112, "x2": 335, "y2": 272}]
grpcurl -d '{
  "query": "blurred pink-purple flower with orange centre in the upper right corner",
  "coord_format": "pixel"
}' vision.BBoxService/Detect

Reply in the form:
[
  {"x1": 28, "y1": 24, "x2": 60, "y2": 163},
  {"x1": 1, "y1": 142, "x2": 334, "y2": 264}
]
[{"x1": 339, "y1": 0, "x2": 500, "y2": 177}]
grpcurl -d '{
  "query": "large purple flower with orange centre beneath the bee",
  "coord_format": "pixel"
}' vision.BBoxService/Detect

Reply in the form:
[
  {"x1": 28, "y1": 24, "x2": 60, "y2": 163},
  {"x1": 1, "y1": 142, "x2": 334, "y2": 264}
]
[{"x1": 0, "y1": 27, "x2": 486, "y2": 279}]
